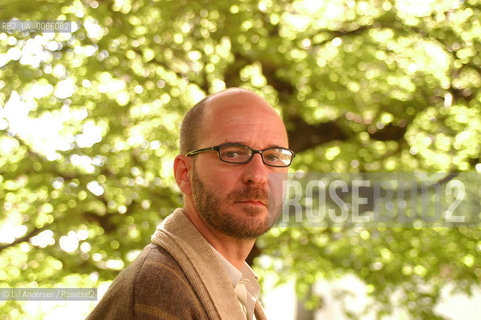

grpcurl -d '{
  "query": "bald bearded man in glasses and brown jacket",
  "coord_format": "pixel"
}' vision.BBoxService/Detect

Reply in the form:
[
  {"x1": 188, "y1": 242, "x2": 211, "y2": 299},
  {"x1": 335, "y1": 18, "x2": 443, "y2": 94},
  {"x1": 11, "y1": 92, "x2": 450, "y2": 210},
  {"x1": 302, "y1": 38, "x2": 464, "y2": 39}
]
[{"x1": 88, "y1": 88, "x2": 294, "y2": 320}]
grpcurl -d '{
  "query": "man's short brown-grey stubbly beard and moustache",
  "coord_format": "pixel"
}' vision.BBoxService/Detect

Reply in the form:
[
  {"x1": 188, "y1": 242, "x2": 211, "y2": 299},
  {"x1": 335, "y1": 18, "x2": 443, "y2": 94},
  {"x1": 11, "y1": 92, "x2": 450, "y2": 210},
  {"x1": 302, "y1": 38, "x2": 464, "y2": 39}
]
[{"x1": 192, "y1": 165, "x2": 281, "y2": 239}]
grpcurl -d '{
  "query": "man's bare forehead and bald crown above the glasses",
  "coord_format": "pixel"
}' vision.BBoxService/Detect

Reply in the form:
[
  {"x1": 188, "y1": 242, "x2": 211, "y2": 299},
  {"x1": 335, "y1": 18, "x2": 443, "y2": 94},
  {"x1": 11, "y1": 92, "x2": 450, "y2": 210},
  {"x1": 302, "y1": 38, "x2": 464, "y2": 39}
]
[{"x1": 202, "y1": 90, "x2": 287, "y2": 148}]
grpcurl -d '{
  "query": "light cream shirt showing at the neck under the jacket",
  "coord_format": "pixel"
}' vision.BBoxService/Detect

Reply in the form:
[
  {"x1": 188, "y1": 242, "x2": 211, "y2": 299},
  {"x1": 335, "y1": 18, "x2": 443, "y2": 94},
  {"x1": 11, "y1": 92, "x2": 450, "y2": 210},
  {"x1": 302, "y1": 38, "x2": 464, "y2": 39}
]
[{"x1": 212, "y1": 247, "x2": 261, "y2": 320}]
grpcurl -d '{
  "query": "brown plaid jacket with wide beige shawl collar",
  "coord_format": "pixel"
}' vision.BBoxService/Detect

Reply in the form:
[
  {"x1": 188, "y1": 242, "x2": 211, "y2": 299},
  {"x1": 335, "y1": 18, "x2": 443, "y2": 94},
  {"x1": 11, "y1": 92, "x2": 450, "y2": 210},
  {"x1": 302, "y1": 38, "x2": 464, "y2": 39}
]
[{"x1": 87, "y1": 209, "x2": 267, "y2": 320}]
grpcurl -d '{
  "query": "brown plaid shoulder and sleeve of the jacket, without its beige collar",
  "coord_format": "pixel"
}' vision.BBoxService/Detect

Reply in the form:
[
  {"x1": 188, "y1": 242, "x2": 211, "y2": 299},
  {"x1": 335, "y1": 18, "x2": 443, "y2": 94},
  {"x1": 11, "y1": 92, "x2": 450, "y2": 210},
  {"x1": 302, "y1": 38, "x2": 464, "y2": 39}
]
[{"x1": 89, "y1": 244, "x2": 204, "y2": 319}]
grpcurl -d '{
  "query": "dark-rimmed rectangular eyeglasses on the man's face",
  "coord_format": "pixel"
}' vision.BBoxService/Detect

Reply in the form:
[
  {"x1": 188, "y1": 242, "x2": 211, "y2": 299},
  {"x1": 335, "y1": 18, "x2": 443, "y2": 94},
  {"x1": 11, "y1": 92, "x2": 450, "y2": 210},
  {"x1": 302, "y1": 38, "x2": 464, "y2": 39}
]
[{"x1": 185, "y1": 142, "x2": 295, "y2": 167}]
